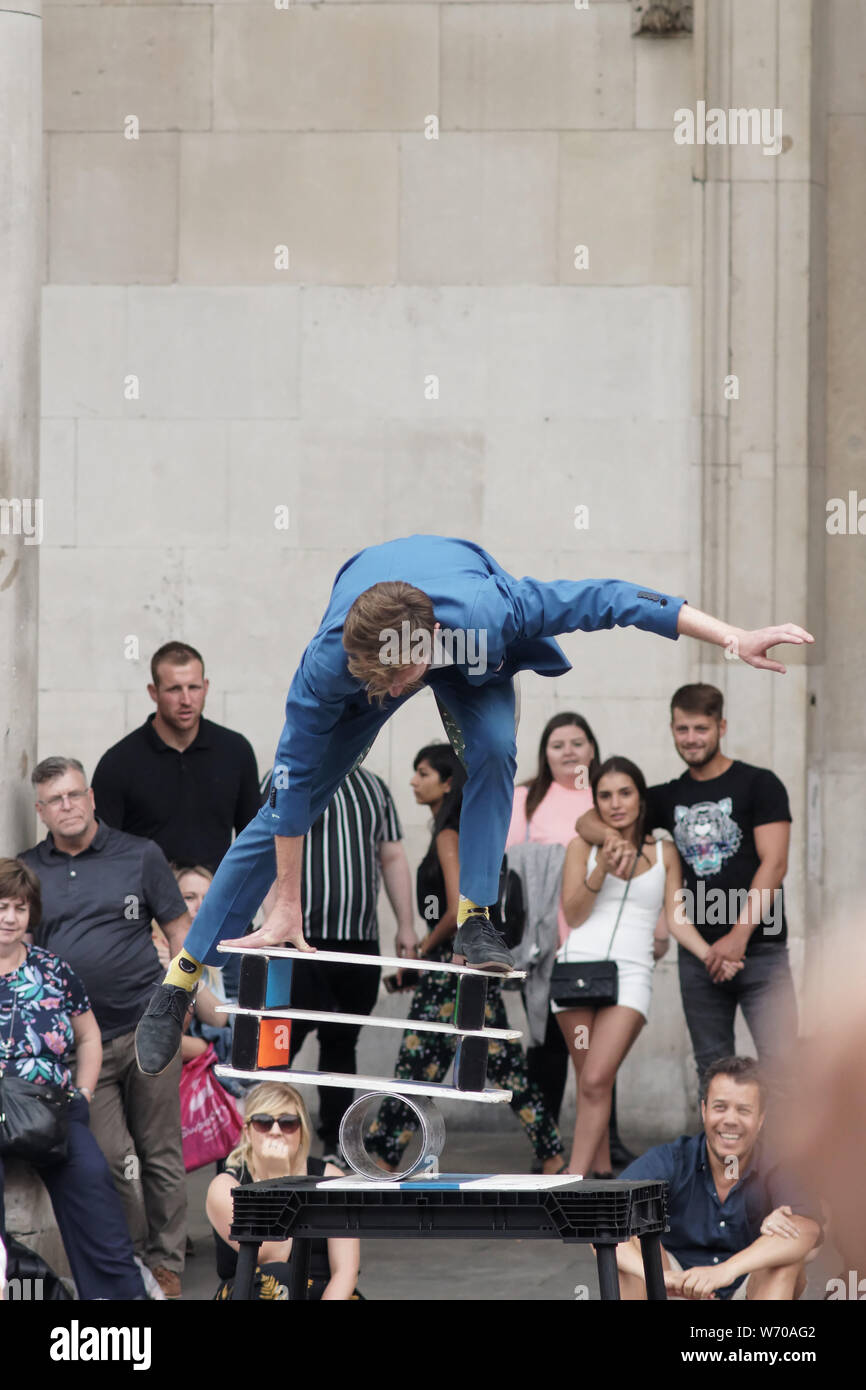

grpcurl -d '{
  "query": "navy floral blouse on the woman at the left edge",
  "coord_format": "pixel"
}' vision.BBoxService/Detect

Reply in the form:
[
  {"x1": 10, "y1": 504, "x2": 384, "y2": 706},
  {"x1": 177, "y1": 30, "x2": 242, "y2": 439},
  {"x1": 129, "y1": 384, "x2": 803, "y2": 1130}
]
[{"x1": 0, "y1": 947, "x2": 90, "y2": 1088}]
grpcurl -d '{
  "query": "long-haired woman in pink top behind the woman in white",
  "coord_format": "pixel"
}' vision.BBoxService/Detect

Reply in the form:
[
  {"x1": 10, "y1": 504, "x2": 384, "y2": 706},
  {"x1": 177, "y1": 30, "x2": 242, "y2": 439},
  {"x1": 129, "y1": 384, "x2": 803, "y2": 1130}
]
[{"x1": 506, "y1": 710, "x2": 600, "y2": 1140}]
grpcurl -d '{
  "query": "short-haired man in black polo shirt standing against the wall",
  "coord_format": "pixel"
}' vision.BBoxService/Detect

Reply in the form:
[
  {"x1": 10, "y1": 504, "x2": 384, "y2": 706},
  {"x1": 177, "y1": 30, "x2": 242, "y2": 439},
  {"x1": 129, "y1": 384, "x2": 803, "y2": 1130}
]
[{"x1": 93, "y1": 642, "x2": 259, "y2": 873}]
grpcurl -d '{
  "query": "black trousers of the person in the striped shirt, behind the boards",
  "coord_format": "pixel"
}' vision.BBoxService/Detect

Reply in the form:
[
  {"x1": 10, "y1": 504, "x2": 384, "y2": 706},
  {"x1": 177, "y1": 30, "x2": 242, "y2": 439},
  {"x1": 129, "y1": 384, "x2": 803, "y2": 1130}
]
[{"x1": 289, "y1": 937, "x2": 381, "y2": 1151}]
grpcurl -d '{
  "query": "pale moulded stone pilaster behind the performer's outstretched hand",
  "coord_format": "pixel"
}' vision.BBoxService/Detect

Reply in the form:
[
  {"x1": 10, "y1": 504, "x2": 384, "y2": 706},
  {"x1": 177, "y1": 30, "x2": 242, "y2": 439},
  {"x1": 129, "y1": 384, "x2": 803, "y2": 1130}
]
[{"x1": 694, "y1": 0, "x2": 824, "y2": 984}]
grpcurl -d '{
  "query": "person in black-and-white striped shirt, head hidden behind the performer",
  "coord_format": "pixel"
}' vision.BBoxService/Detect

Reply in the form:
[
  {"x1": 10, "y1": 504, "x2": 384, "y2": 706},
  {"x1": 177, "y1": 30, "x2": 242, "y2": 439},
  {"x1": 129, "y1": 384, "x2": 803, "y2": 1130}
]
[{"x1": 264, "y1": 767, "x2": 418, "y2": 1162}]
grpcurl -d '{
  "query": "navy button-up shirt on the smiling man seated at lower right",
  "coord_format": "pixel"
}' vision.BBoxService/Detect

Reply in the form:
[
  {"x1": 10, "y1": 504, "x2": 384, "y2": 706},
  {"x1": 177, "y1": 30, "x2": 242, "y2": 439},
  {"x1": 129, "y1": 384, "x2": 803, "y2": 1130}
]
[{"x1": 620, "y1": 1134, "x2": 820, "y2": 1298}]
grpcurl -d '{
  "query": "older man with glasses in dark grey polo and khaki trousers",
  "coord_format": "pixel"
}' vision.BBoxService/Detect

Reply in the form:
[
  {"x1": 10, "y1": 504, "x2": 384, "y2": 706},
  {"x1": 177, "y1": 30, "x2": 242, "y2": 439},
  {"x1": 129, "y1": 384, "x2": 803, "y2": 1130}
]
[{"x1": 18, "y1": 758, "x2": 189, "y2": 1298}]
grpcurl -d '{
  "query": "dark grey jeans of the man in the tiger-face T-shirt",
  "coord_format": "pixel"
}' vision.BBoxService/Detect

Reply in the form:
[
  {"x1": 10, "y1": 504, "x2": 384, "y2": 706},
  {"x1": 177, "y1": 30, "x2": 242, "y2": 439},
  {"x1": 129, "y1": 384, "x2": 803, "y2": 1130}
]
[{"x1": 680, "y1": 945, "x2": 796, "y2": 1087}]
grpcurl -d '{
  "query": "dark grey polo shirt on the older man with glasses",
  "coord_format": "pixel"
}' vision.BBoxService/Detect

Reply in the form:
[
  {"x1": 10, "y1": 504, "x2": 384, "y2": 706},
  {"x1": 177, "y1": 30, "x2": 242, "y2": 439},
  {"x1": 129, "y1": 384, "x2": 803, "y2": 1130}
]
[{"x1": 18, "y1": 821, "x2": 186, "y2": 1043}]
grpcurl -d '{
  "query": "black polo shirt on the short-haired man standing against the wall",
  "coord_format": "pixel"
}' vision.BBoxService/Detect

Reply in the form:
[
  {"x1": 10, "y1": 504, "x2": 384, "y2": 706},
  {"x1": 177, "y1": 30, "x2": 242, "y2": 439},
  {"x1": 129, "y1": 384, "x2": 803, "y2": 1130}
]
[{"x1": 93, "y1": 714, "x2": 259, "y2": 873}]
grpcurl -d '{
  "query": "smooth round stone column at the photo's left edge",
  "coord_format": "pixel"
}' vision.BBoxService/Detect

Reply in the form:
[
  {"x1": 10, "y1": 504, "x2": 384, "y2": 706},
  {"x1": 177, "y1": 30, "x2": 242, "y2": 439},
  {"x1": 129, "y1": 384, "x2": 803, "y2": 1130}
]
[{"x1": 0, "y1": 0, "x2": 44, "y2": 855}]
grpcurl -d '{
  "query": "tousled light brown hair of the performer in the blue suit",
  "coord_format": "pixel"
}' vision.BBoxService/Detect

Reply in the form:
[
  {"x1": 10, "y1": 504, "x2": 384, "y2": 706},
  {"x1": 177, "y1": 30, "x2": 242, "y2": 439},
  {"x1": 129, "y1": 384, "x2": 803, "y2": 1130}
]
[{"x1": 343, "y1": 580, "x2": 436, "y2": 705}]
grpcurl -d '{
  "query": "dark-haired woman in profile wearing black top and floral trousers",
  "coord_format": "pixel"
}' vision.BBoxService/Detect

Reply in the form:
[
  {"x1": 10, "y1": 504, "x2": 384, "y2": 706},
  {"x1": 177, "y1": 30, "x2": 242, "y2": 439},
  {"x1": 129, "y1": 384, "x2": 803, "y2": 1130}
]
[{"x1": 367, "y1": 744, "x2": 563, "y2": 1173}]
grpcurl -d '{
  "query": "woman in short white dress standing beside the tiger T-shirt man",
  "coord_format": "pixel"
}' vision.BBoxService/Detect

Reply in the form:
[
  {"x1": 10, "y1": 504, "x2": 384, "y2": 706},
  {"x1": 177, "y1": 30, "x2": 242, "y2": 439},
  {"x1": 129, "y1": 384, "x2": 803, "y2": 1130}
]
[{"x1": 550, "y1": 758, "x2": 742, "y2": 1177}]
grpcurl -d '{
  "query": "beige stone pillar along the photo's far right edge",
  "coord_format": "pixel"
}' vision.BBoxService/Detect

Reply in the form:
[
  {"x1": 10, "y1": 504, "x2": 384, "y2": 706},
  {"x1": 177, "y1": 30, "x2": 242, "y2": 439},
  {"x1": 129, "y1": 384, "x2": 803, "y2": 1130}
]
[{"x1": 815, "y1": 0, "x2": 866, "y2": 956}]
